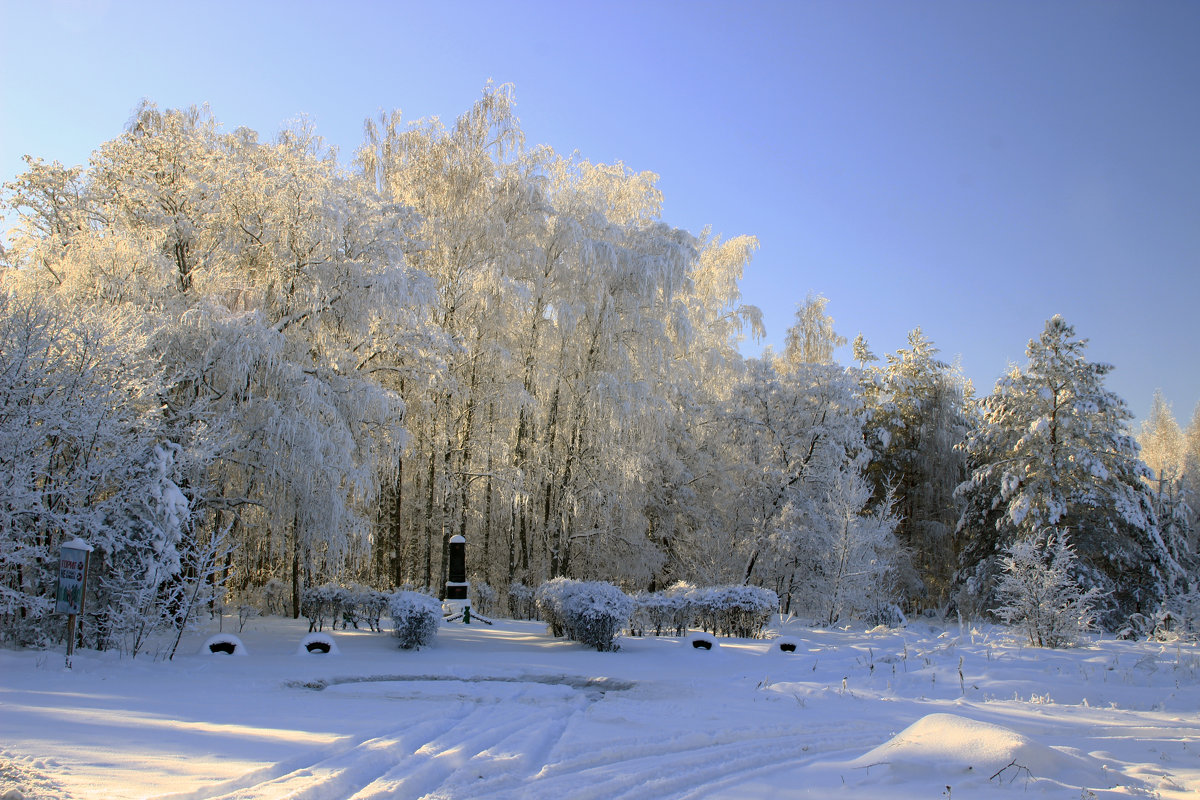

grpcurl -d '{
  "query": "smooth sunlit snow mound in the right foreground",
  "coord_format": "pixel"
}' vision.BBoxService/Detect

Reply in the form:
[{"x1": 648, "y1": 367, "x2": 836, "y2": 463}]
[{"x1": 850, "y1": 714, "x2": 1114, "y2": 788}]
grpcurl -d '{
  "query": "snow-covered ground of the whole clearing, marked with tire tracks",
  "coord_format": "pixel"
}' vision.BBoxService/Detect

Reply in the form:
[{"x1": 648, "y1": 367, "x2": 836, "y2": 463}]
[{"x1": 0, "y1": 618, "x2": 1200, "y2": 800}]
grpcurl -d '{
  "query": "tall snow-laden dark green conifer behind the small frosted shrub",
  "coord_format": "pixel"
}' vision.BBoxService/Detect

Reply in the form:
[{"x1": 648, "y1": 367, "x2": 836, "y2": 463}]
[{"x1": 958, "y1": 317, "x2": 1178, "y2": 627}]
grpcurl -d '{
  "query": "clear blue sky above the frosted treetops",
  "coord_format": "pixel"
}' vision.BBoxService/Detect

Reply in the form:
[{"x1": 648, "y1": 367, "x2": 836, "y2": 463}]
[{"x1": 0, "y1": 0, "x2": 1200, "y2": 425}]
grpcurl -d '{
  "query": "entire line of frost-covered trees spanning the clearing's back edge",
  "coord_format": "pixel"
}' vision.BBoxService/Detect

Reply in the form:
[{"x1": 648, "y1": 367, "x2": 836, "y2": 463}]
[{"x1": 0, "y1": 86, "x2": 1200, "y2": 646}]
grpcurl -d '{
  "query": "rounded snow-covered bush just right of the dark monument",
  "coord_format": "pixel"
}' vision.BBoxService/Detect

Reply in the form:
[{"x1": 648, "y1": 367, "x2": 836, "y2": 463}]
[{"x1": 535, "y1": 578, "x2": 634, "y2": 652}]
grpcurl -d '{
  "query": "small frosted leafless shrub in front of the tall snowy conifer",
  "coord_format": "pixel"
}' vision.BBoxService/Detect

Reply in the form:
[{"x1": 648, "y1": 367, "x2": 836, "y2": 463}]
[{"x1": 994, "y1": 530, "x2": 1099, "y2": 648}]
